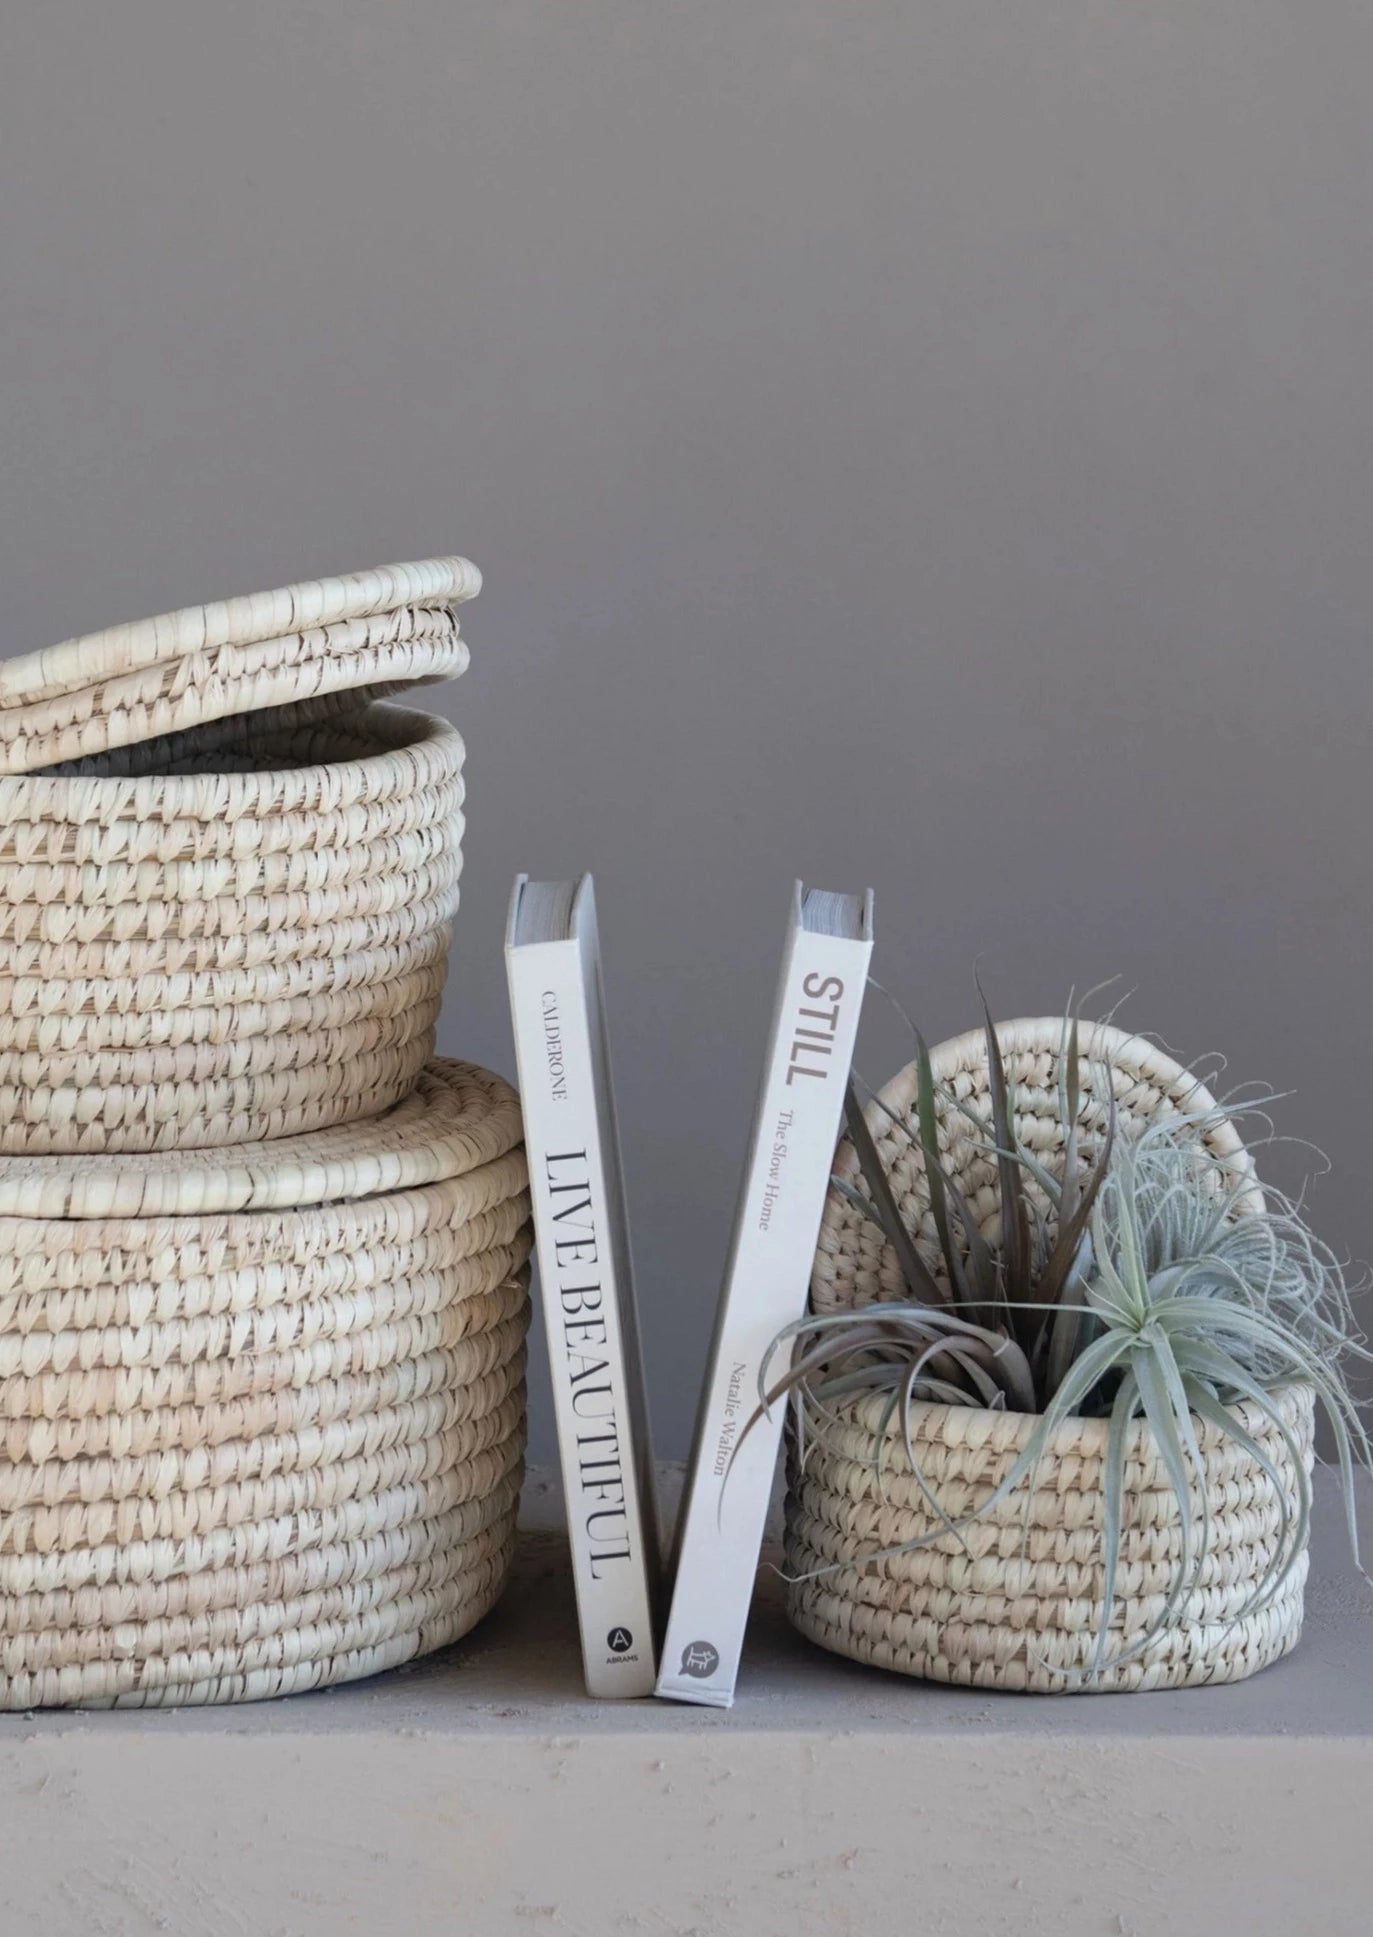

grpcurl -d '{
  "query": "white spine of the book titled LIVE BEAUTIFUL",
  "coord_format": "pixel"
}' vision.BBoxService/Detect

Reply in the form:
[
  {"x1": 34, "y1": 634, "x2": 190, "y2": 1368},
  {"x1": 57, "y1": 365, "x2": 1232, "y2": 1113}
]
[{"x1": 505, "y1": 941, "x2": 656, "y2": 1697}]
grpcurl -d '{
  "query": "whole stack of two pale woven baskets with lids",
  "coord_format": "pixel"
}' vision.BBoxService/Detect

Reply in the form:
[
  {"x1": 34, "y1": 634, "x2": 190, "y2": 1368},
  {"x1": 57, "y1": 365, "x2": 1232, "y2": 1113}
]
[{"x1": 0, "y1": 560, "x2": 529, "y2": 1706}]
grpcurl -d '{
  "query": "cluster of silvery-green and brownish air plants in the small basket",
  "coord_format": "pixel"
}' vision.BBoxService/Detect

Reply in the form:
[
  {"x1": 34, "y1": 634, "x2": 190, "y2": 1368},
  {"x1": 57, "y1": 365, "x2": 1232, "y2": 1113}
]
[{"x1": 759, "y1": 1005, "x2": 1373, "y2": 1676}]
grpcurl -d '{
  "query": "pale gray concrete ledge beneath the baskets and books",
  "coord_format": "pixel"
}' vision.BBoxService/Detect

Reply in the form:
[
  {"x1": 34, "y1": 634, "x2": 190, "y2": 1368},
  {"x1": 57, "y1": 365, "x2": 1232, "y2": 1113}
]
[{"x1": 0, "y1": 1474, "x2": 1373, "y2": 1937}]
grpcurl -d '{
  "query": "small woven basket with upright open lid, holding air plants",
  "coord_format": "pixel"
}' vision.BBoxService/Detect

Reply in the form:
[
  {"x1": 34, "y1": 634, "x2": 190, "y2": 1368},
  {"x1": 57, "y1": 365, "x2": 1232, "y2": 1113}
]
[{"x1": 786, "y1": 1017, "x2": 1313, "y2": 1693}]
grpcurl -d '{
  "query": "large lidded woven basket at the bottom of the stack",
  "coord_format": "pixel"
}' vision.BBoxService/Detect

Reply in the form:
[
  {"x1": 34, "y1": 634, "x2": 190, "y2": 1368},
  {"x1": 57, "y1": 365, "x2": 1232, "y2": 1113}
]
[{"x1": 0, "y1": 1061, "x2": 529, "y2": 1708}]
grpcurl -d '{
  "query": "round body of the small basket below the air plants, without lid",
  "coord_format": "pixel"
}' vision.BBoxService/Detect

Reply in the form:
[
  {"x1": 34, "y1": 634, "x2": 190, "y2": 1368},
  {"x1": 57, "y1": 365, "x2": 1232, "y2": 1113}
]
[{"x1": 786, "y1": 1387, "x2": 1313, "y2": 1693}]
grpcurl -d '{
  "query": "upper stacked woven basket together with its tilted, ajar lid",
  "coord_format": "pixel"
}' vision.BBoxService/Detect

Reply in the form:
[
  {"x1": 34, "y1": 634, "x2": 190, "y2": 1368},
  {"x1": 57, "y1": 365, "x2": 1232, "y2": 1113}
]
[{"x1": 0, "y1": 560, "x2": 478, "y2": 1154}]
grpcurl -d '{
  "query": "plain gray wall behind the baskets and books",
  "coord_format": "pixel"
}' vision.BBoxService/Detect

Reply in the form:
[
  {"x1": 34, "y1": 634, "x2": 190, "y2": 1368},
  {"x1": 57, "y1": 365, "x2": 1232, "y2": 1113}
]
[{"x1": 0, "y1": 0, "x2": 1373, "y2": 1453}]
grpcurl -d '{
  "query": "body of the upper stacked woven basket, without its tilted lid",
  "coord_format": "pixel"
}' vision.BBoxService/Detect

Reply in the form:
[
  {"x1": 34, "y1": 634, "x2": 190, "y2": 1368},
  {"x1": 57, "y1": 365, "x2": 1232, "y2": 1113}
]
[{"x1": 0, "y1": 705, "x2": 463, "y2": 1154}]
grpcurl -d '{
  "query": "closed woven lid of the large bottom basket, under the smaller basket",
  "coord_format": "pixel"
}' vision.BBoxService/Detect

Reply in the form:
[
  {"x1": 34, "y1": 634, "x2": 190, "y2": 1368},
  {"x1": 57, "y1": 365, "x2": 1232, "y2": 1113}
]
[{"x1": 0, "y1": 1058, "x2": 523, "y2": 1218}]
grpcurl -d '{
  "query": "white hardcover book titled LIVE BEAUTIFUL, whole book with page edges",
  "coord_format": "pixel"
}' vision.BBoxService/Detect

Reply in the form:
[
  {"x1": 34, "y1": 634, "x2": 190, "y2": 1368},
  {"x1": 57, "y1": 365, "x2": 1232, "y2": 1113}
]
[{"x1": 505, "y1": 874, "x2": 660, "y2": 1697}]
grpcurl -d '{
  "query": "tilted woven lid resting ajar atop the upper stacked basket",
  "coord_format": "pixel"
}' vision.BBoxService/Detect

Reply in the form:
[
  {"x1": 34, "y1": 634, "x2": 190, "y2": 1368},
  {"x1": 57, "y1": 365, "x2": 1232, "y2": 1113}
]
[{"x1": 0, "y1": 558, "x2": 482, "y2": 775}]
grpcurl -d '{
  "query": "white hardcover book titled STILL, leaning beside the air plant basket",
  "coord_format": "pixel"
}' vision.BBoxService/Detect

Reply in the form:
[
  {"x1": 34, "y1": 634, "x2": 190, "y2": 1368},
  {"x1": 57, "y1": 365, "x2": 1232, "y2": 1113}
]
[{"x1": 656, "y1": 881, "x2": 871, "y2": 1708}]
